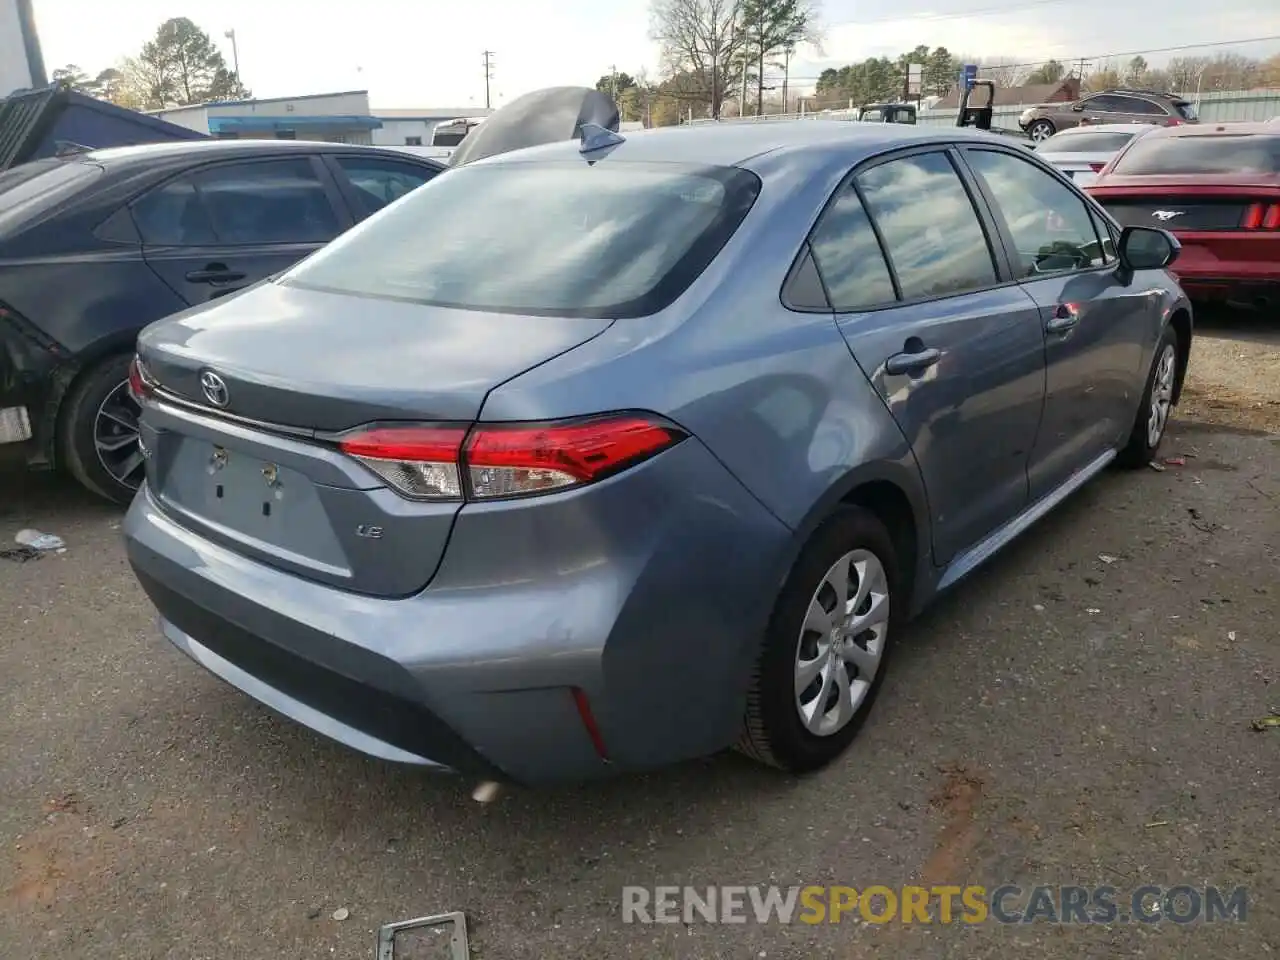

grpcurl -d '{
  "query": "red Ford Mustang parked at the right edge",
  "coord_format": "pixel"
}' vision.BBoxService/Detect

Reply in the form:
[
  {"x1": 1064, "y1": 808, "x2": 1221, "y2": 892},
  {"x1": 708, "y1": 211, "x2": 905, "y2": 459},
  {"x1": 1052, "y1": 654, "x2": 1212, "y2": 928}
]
[{"x1": 1087, "y1": 122, "x2": 1280, "y2": 308}]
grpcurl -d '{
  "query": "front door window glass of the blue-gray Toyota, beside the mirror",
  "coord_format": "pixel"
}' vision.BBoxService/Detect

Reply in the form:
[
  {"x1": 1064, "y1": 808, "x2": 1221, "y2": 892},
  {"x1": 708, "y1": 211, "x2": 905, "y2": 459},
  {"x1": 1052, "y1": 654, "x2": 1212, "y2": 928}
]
[{"x1": 966, "y1": 150, "x2": 1106, "y2": 276}]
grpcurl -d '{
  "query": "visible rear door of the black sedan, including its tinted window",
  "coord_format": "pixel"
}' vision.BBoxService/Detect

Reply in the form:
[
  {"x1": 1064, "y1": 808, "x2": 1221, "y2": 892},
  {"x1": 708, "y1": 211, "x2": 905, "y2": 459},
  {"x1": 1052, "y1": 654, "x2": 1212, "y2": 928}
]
[{"x1": 131, "y1": 154, "x2": 352, "y2": 305}]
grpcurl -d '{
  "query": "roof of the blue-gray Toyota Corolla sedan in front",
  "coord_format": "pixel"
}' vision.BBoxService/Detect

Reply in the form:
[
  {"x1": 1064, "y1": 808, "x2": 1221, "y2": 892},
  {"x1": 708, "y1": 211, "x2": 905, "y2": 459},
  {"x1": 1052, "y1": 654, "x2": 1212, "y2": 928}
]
[{"x1": 475, "y1": 120, "x2": 1018, "y2": 166}]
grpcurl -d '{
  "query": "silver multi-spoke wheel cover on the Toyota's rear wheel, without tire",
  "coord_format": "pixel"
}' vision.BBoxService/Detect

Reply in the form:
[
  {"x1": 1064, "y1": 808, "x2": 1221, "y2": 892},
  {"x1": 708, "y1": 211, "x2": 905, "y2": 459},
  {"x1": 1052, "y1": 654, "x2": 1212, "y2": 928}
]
[{"x1": 795, "y1": 549, "x2": 890, "y2": 737}]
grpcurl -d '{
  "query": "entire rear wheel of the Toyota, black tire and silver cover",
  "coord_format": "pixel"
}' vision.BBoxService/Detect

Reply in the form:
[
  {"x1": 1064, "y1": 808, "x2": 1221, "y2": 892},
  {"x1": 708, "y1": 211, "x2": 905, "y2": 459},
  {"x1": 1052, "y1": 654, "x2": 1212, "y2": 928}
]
[{"x1": 737, "y1": 507, "x2": 901, "y2": 773}]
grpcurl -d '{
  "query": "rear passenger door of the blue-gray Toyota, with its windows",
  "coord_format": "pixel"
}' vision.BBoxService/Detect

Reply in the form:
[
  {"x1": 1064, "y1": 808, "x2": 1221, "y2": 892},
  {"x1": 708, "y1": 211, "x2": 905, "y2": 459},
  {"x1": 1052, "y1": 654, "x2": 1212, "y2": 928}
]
[{"x1": 812, "y1": 148, "x2": 1044, "y2": 566}]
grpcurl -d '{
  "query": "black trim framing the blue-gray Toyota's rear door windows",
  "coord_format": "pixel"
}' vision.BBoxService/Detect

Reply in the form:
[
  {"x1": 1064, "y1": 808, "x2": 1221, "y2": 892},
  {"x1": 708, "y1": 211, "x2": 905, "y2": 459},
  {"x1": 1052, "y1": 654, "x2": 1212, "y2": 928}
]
[{"x1": 780, "y1": 141, "x2": 1019, "y2": 316}]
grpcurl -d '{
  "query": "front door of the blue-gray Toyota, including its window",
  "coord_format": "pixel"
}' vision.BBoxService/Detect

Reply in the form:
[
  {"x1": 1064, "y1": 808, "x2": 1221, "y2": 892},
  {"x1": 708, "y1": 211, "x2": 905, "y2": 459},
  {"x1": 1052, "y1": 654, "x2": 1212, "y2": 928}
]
[{"x1": 963, "y1": 147, "x2": 1160, "y2": 499}]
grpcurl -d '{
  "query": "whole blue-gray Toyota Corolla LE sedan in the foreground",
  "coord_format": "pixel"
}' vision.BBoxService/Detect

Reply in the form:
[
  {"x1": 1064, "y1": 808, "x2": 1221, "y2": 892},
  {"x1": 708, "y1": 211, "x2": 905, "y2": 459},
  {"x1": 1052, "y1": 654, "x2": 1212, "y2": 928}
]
[{"x1": 125, "y1": 96, "x2": 1192, "y2": 783}]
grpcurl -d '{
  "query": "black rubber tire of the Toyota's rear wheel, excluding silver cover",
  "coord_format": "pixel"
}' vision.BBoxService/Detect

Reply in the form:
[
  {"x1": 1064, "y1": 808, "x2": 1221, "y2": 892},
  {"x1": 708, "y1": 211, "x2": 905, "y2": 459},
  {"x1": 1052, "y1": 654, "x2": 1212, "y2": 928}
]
[{"x1": 736, "y1": 507, "x2": 904, "y2": 773}]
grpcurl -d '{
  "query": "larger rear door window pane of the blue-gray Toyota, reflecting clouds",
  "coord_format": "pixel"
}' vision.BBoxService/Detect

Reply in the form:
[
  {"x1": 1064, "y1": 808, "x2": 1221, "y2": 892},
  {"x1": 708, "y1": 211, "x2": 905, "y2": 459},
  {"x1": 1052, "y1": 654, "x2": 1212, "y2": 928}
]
[{"x1": 858, "y1": 152, "x2": 997, "y2": 300}]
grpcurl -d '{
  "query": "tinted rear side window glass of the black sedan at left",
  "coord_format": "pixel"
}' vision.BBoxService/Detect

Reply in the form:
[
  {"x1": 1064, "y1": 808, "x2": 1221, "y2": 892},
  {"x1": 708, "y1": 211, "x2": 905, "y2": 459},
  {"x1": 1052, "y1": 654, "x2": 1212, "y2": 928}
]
[{"x1": 133, "y1": 159, "x2": 342, "y2": 247}]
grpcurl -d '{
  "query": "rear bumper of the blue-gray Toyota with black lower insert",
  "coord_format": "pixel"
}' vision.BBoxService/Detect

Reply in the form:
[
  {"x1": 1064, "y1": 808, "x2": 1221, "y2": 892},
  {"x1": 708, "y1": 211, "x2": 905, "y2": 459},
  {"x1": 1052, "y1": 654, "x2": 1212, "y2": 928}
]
[{"x1": 124, "y1": 440, "x2": 791, "y2": 783}]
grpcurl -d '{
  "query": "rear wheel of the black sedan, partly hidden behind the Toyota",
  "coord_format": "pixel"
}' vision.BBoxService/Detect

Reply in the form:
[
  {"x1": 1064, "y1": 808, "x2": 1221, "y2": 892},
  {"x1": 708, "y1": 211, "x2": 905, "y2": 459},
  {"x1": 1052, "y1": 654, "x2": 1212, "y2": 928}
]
[{"x1": 60, "y1": 355, "x2": 145, "y2": 504}]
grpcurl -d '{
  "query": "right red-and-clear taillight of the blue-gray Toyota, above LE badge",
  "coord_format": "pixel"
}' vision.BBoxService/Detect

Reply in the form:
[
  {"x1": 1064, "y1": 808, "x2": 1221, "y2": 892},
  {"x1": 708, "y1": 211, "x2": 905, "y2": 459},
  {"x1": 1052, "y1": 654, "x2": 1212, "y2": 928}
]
[{"x1": 338, "y1": 413, "x2": 686, "y2": 500}]
